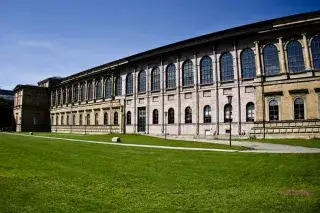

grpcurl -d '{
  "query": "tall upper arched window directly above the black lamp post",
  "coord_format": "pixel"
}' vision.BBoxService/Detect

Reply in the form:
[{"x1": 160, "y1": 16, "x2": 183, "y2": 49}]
[{"x1": 220, "y1": 52, "x2": 234, "y2": 81}]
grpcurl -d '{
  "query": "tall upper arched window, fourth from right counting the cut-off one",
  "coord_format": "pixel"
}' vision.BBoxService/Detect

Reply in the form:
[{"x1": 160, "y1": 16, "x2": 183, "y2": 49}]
[{"x1": 241, "y1": 48, "x2": 256, "y2": 78}]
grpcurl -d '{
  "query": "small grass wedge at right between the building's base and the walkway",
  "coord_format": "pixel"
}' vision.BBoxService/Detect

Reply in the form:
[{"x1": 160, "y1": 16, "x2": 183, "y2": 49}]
[{"x1": 236, "y1": 139, "x2": 320, "y2": 148}]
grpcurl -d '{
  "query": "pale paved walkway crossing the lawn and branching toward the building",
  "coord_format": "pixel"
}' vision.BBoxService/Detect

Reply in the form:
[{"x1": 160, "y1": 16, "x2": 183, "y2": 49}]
[{"x1": 0, "y1": 132, "x2": 320, "y2": 153}]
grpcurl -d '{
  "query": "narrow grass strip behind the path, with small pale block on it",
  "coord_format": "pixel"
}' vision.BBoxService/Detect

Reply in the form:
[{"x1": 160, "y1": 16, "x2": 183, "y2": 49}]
[{"x1": 24, "y1": 132, "x2": 248, "y2": 150}]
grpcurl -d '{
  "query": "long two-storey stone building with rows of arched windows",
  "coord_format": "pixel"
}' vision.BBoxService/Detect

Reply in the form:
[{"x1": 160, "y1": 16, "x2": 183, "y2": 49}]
[{"x1": 15, "y1": 11, "x2": 320, "y2": 137}]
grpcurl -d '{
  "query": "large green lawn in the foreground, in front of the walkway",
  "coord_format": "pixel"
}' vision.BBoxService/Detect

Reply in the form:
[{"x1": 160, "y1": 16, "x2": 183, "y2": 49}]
[{"x1": 0, "y1": 133, "x2": 320, "y2": 213}]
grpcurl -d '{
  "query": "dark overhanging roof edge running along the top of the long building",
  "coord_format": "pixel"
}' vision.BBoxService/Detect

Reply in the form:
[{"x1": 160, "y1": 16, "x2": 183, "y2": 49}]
[{"x1": 61, "y1": 10, "x2": 320, "y2": 83}]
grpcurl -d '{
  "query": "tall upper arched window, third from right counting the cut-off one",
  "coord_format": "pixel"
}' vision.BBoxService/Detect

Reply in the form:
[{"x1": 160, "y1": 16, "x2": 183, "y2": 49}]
[{"x1": 263, "y1": 44, "x2": 280, "y2": 76}]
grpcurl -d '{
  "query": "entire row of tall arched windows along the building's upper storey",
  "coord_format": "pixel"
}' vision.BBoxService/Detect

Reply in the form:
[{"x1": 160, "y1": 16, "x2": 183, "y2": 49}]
[{"x1": 54, "y1": 36, "x2": 320, "y2": 103}]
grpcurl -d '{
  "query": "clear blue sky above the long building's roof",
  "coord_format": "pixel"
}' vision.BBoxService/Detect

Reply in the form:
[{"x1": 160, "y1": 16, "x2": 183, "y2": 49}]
[{"x1": 0, "y1": 0, "x2": 320, "y2": 89}]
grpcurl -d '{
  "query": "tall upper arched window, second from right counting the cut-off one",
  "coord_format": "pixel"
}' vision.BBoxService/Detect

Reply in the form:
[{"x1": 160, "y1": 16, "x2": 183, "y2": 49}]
[{"x1": 287, "y1": 40, "x2": 305, "y2": 72}]
